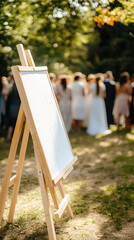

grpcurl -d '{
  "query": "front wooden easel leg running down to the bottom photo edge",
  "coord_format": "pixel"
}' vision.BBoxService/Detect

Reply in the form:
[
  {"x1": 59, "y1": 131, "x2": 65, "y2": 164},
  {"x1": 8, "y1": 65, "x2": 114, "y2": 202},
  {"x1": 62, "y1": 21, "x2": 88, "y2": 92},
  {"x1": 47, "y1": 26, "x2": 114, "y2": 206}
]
[{"x1": 35, "y1": 153, "x2": 56, "y2": 240}]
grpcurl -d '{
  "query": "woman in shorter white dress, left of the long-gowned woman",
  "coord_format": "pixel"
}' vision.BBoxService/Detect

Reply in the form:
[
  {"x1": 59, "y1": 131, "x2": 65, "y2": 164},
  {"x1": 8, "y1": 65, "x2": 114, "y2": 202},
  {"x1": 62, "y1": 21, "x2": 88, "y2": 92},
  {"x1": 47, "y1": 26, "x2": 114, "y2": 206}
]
[{"x1": 70, "y1": 75, "x2": 86, "y2": 131}]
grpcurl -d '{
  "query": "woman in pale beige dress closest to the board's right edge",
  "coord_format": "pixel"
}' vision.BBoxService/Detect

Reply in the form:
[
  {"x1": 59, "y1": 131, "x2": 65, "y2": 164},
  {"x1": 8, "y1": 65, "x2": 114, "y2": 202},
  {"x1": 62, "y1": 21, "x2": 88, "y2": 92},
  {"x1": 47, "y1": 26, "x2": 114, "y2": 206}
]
[{"x1": 56, "y1": 78, "x2": 72, "y2": 132}]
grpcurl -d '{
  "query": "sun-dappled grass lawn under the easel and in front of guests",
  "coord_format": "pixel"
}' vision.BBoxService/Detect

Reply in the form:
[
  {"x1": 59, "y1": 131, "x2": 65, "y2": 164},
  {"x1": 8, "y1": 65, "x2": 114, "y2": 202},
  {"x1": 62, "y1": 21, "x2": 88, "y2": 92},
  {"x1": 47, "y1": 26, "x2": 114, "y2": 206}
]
[{"x1": 0, "y1": 126, "x2": 134, "y2": 240}]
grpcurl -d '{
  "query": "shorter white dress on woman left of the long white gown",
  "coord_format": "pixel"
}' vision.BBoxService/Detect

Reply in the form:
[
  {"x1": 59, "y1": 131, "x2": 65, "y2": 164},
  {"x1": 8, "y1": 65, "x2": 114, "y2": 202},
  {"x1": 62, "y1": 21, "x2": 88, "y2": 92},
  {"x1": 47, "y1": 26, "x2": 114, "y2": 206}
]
[{"x1": 69, "y1": 81, "x2": 86, "y2": 120}]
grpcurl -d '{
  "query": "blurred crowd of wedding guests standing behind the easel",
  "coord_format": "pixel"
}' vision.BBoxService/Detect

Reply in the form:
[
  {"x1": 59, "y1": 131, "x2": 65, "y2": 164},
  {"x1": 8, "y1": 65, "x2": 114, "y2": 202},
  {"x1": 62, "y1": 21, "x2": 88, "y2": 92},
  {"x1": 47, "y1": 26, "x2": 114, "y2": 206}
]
[{"x1": 0, "y1": 71, "x2": 134, "y2": 142}]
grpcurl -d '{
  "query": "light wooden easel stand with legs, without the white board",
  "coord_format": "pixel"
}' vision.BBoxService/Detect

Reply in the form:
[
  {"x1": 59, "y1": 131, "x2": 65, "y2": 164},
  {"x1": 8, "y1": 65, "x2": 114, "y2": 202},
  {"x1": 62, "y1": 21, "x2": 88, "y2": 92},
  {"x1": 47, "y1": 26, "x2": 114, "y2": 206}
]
[{"x1": 0, "y1": 44, "x2": 73, "y2": 240}]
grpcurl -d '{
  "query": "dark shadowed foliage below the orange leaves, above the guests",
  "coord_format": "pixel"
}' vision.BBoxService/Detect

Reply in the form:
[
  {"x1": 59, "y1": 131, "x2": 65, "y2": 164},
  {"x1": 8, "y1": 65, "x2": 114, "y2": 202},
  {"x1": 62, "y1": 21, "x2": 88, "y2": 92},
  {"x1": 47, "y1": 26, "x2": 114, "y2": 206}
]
[{"x1": 95, "y1": 23, "x2": 134, "y2": 80}]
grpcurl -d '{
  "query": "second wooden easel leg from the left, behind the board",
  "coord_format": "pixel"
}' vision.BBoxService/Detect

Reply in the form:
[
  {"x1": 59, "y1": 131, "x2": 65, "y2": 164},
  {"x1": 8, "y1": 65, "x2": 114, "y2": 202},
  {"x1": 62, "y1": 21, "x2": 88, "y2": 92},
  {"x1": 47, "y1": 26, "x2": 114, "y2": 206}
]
[{"x1": 8, "y1": 121, "x2": 29, "y2": 223}]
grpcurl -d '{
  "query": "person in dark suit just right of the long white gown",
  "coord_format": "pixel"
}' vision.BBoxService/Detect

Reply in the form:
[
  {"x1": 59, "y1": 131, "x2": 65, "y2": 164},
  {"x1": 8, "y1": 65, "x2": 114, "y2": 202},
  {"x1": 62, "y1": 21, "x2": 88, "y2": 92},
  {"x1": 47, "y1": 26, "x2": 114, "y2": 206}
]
[{"x1": 104, "y1": 71, "x2": 116, "y2": 126}]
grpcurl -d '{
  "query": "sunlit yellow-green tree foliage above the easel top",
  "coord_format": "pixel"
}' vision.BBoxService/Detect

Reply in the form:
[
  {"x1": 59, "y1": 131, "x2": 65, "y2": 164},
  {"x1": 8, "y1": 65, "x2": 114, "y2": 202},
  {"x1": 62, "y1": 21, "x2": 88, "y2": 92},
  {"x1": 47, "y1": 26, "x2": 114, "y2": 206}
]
[{"x1": 0, "y1": 0, "x2": 91, "y2": 75}]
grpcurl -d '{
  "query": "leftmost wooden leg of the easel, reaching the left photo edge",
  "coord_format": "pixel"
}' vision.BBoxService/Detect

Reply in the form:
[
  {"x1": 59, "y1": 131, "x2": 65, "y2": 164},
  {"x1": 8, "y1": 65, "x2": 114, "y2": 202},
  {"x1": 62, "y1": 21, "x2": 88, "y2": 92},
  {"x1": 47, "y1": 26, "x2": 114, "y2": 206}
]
[{"x1": 0, "y1": 105, "x2": 24, "y2": 222}]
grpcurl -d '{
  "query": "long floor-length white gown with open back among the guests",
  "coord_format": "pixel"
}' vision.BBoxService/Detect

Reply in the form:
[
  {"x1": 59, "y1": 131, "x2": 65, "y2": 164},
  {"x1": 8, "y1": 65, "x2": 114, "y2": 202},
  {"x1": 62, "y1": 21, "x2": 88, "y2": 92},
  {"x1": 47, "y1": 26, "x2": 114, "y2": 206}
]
[{"x1": 87, "y1": 83, "x2": 108, "y2": 135}]
